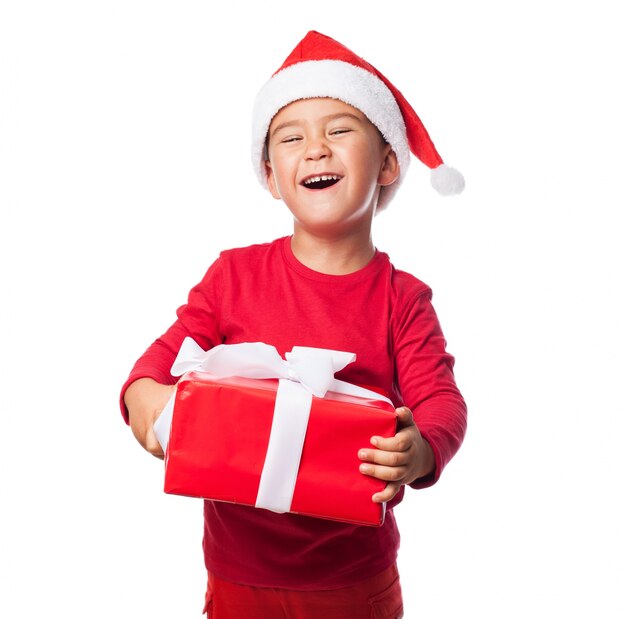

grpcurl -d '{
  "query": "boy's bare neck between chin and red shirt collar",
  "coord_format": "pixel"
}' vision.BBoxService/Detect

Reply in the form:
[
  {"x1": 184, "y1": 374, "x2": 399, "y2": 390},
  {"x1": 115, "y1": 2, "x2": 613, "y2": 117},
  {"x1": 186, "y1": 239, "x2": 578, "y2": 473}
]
[{"x1": 291, "y1": 226, "x2": 376, "y2": 275}]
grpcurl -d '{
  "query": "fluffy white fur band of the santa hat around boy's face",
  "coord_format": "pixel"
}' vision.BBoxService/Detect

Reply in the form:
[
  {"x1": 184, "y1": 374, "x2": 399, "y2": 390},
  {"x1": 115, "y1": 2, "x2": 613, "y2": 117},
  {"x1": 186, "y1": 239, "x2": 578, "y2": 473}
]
[{"x1": 252, "y1": 60, "x2": 411, "y2": 210}]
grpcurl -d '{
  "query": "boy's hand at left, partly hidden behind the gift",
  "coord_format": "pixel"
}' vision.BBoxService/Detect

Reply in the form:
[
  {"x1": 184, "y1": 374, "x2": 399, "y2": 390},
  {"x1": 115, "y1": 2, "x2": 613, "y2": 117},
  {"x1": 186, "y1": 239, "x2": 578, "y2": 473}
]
[{"x1": 124, "y1": 378, "x2": 176, "y2": 460}]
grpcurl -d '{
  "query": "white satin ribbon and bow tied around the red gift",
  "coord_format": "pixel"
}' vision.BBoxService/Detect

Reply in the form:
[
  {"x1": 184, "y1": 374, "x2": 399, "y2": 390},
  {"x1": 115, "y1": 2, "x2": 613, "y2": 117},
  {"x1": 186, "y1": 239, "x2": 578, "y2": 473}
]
[{"x1": 154, "y1": 337, "x2": 391, "y2": 513}]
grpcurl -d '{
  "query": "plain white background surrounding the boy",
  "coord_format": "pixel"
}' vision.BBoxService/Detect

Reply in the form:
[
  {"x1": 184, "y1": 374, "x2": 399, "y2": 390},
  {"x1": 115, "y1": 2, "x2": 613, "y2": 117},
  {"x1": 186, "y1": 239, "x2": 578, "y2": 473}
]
[{"x1": 0, "y1": 0, "x2": 626, "y2": 619}]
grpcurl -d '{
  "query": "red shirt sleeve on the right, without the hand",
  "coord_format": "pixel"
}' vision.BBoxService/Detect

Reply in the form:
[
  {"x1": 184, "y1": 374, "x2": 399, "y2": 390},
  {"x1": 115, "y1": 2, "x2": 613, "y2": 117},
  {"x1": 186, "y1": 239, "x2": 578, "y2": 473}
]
[{"x1": 392, "y1": 288, "x2": 467, "y2": 488}]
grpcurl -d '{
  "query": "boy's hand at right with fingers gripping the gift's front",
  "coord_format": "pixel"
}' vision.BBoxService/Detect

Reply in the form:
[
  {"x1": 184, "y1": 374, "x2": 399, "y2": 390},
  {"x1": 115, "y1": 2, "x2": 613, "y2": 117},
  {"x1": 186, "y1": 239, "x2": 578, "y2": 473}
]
[{"x1": 359, "y1": 406, "x2": 435, "y2": 503}]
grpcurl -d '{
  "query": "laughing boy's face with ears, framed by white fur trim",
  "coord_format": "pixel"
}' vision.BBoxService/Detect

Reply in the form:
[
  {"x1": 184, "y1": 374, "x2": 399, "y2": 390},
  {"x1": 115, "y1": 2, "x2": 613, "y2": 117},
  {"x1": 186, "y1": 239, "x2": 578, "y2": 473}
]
[{"x1": 266, "y1": 98, "x2": 399, "y2": 236}]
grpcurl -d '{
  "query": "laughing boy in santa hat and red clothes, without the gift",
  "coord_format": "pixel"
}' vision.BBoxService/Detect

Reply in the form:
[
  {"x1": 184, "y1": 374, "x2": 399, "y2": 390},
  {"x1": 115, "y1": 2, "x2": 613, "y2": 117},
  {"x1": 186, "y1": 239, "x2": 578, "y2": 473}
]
[{"x1": 121, "y1": 32, "x2": 466, "y2": 619}]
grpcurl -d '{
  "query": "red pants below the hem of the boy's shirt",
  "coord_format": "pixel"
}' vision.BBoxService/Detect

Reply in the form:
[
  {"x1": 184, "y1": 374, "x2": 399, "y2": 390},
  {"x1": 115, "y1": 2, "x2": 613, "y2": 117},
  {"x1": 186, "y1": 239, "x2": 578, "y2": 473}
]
[{"x1": 204, "y1": 565, "x2": 403, "y2": 619}]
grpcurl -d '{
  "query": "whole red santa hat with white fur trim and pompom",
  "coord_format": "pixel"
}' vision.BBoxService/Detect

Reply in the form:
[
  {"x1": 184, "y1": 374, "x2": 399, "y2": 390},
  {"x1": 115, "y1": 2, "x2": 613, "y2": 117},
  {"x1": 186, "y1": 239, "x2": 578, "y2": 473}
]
[{"x1": 252, "y1": 30, "x2": 465, "y2": 210}]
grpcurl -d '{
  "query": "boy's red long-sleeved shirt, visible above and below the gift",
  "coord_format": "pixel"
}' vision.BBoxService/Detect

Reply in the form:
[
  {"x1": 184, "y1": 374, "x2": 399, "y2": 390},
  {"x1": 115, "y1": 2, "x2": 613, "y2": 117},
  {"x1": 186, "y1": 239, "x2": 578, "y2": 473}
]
[{"x1": 120, "y1": 237, "x2": 466, "y2": 589}]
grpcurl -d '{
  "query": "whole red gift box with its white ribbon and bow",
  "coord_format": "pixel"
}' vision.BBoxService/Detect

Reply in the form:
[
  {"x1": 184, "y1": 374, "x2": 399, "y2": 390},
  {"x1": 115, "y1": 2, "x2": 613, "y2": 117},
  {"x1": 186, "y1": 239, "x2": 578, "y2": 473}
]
[{"x1": 158, "y1": 345, "x2": 396, "y2": 526}]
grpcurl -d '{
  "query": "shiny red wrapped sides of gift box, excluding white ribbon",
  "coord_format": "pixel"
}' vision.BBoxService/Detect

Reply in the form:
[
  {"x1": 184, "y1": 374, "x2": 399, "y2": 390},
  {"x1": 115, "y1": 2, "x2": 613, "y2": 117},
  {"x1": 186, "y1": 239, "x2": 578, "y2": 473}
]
[{"x1": 165, "y1": 371, "x2": 396, "y2": 525}]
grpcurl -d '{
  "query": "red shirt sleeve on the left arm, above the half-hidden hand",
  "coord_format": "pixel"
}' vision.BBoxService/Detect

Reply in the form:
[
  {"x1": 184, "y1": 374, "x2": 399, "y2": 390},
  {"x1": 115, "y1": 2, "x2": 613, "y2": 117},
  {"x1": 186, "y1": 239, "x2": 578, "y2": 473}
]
[{"x1": 120, "y1": 259, "x2": 223, "y2": 423}]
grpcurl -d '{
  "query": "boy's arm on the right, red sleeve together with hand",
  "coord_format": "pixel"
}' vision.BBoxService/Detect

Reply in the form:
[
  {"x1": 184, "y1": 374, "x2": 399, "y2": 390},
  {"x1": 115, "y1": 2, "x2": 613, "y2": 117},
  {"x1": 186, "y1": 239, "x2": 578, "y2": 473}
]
[{"x1": 359, "y1": 289, "x2": 467, "y2": 502}]
